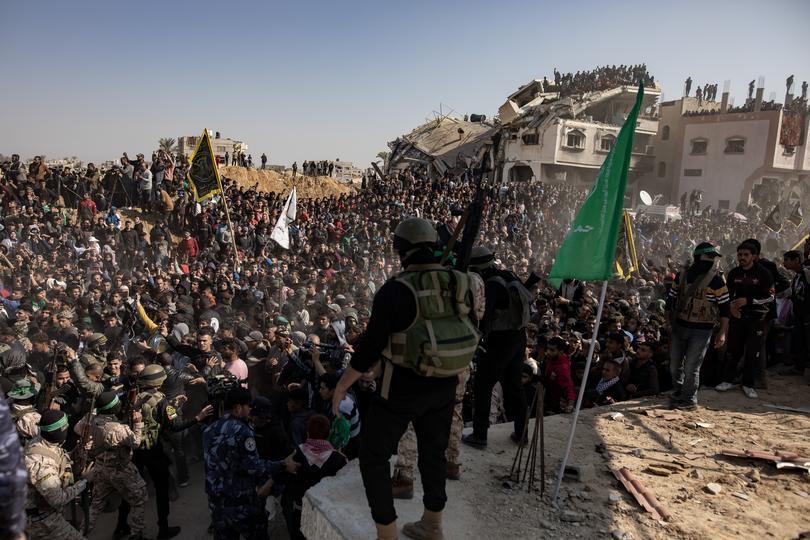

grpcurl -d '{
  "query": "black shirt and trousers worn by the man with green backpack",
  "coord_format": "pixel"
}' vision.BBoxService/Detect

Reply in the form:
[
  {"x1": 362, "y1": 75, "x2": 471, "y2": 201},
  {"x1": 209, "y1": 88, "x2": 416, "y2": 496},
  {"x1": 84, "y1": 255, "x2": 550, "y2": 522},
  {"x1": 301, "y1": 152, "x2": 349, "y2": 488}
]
[{"x1": 351, "y1": 272, "x2": 458, "y2": 525}]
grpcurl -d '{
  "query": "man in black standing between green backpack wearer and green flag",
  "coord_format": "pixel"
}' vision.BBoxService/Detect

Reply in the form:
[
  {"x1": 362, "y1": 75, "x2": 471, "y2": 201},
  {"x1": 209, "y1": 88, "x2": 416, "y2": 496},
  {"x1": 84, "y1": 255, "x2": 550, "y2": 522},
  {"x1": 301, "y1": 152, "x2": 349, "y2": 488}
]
[{"x1": 462, "y1": 246, "x2": 540, "y2": 449}]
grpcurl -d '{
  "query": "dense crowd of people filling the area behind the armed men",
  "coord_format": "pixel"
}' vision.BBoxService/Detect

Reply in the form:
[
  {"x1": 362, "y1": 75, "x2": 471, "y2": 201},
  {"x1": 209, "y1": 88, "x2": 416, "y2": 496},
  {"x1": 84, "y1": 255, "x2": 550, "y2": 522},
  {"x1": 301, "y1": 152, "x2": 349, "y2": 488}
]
[{"x1": 0, "y1": 148, "x2": 810, "y2": 538}]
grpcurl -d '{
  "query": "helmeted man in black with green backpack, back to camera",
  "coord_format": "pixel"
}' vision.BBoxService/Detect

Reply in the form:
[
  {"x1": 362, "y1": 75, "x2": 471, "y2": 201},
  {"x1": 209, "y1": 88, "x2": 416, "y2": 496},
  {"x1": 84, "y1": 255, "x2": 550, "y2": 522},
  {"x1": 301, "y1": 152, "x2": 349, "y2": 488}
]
[{"x1": 333, "y1": 218, "x2": 478, "y2": 540}]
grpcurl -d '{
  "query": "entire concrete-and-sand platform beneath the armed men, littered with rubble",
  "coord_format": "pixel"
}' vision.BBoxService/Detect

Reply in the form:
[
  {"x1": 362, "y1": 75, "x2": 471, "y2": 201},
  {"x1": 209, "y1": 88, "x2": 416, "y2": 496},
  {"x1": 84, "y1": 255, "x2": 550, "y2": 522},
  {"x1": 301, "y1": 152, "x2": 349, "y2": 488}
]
[{"x1": 305, "y1": 377, "x2": 810, "y2": 540}]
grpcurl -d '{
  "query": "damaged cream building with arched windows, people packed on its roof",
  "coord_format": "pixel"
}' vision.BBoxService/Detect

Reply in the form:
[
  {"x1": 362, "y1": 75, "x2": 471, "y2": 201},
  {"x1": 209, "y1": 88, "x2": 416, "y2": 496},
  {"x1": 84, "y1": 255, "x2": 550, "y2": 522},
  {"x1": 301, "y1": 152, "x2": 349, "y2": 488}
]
[{"x1": 496, "y1": 80, "x2": 661, "y2": 194}]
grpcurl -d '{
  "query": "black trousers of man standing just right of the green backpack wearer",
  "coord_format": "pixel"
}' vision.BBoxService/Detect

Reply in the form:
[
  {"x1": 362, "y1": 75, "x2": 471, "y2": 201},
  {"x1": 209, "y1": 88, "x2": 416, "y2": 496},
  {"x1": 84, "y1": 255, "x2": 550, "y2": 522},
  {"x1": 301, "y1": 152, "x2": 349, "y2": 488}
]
[{"x1": 473, "y1": 330, "x2": 526, "y2": 440}]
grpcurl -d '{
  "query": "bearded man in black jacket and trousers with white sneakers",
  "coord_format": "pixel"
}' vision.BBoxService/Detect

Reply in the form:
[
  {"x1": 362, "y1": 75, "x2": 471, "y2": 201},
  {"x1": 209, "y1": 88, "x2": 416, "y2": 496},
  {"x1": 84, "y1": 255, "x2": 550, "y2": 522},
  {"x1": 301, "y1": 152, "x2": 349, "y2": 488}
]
[{"x1": 715, "y1": 242, "x2": 774, "y2": 399}]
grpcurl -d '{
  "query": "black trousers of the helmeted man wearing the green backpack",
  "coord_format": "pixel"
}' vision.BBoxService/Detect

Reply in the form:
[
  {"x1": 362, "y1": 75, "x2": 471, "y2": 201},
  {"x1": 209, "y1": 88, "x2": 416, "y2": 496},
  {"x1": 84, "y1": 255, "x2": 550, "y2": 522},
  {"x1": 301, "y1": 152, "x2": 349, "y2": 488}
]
[{"x1": 360, "y1": 376, "x2": 457, "y2": 525}]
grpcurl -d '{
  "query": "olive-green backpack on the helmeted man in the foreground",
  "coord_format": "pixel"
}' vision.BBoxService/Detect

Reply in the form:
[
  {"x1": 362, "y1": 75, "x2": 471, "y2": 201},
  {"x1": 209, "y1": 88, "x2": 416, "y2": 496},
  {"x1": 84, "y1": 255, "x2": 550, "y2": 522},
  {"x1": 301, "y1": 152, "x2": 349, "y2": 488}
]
[{"x1": 383, "y1": 265, "x2": 480, "y2": 397}]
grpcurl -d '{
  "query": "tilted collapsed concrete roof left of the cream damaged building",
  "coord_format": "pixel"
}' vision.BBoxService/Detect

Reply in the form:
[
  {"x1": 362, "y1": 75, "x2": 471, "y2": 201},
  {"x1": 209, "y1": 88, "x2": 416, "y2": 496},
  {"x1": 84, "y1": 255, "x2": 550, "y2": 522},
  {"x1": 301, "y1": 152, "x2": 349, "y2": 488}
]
[{"x1": 388, "y1": 116, "x2": 498, "y2": 176}]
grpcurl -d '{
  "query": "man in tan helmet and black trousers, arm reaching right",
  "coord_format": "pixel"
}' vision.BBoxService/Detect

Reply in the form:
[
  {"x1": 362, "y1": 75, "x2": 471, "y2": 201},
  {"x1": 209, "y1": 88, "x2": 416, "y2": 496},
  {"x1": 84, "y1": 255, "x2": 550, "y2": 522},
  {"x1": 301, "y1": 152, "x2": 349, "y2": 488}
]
[{"x1": 115, "y1": 364, "x2": 214, "y2": 538}]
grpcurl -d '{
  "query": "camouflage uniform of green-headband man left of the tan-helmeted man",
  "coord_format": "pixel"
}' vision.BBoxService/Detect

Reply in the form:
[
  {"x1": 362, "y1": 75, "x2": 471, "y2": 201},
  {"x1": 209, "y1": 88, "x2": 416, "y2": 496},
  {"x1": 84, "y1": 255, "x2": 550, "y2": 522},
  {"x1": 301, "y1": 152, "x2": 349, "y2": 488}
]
[{"x1": 75, "y1": 414, "x2": 147, "y2": 536}]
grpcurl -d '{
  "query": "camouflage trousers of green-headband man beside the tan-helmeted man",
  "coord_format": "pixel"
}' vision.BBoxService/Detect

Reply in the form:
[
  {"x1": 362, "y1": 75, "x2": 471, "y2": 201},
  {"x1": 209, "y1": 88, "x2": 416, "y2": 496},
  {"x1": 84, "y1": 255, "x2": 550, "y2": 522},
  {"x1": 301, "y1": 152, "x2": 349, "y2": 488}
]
[{"x1": 90, "y1": 462, "x2": 147, "y2": 535}]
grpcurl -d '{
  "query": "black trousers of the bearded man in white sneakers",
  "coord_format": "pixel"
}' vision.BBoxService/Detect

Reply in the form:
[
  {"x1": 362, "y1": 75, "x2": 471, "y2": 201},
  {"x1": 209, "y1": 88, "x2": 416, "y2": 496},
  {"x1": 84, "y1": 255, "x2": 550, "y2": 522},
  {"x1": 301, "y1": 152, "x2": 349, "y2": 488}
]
[{"x1": 723, "y1": 318, "x2": 768, "y2": 388}]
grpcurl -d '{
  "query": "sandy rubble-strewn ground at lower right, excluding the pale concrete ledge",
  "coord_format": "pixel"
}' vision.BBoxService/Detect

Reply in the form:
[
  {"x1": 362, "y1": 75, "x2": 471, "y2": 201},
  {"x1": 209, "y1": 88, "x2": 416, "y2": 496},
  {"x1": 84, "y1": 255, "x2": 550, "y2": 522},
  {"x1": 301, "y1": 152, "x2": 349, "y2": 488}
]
[{"x1": 460, "y1": 377, "x2": 810, "y2": 539}]
